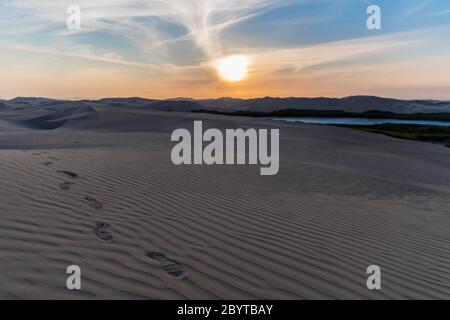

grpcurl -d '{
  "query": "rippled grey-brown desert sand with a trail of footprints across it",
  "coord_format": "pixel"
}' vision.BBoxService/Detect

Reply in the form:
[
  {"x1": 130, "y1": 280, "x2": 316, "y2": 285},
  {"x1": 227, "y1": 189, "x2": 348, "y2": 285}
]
[{"x1": 0, "y1": 106, "x2": 450, "y2": 299}]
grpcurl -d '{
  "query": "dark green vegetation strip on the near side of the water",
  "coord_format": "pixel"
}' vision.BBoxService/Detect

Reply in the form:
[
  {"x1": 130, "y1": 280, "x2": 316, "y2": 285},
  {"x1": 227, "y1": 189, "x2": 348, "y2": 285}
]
[{"x1": 339, "y1": 124, "x2": 450, "y2": 148}]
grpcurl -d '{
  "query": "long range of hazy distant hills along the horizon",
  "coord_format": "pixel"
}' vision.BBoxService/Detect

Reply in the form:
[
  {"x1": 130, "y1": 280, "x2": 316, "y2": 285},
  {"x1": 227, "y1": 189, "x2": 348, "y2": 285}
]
[{"x1": 8, "y1": 96, "x2": 450, "y2": 113}]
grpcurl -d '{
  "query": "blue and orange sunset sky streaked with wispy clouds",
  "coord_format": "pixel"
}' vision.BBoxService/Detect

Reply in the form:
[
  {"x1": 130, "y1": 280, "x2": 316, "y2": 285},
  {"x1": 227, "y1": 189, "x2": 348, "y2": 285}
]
[{"x1": 0, "y1": 0, "x2": 450, "y2": 100}]
